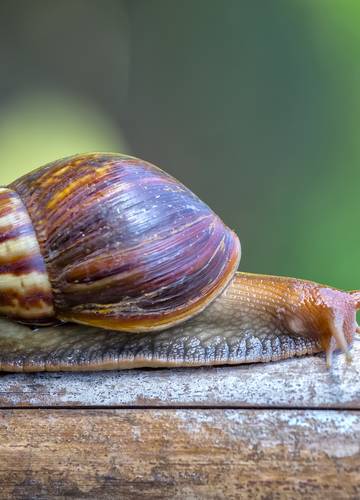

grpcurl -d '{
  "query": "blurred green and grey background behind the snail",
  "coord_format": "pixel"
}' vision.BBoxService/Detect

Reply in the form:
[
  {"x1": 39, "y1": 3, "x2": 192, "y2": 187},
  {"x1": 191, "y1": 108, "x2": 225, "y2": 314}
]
[{"x1": 0, "y1": 0, "x2": 360, "y2": 288}]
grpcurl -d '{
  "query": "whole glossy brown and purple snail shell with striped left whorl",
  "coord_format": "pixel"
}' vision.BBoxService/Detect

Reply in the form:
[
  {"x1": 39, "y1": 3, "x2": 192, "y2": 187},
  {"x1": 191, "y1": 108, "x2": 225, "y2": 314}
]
[{"x1": 0, "y1": 154, "x2": 240, "y2": 331}]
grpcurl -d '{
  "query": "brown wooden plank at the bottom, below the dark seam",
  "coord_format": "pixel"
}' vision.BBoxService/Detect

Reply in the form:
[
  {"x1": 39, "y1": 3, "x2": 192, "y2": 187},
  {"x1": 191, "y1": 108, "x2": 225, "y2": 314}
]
[{"x1": 0, "y1": 409, "x2": 360, "y2": 499}]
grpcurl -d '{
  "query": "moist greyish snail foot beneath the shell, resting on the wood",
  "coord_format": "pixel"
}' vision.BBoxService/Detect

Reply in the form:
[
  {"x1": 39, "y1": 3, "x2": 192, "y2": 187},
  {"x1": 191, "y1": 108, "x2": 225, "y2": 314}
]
[{"x1": 0, "y1": 318, "x2": 321, "y2": 372}]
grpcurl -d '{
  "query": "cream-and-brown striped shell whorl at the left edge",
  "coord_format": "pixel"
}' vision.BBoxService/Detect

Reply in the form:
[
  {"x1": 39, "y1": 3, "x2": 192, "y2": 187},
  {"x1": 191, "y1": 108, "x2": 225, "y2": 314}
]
[{"x1": 0, "y1": 188, "x2": 54, "y2": 324}]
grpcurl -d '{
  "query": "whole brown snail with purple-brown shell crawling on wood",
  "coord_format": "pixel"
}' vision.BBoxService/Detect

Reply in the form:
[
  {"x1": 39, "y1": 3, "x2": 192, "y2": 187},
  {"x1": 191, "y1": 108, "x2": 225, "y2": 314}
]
[{"x1": 0, "y1": 153, "x2": 360, "y2": 371}]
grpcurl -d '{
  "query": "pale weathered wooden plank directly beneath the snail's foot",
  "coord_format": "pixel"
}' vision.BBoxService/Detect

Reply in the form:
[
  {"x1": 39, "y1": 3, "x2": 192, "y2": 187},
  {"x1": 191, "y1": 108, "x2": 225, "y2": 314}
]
[{"x1": 0, "y1": 339, "x2": 360, "y2": 409}]
